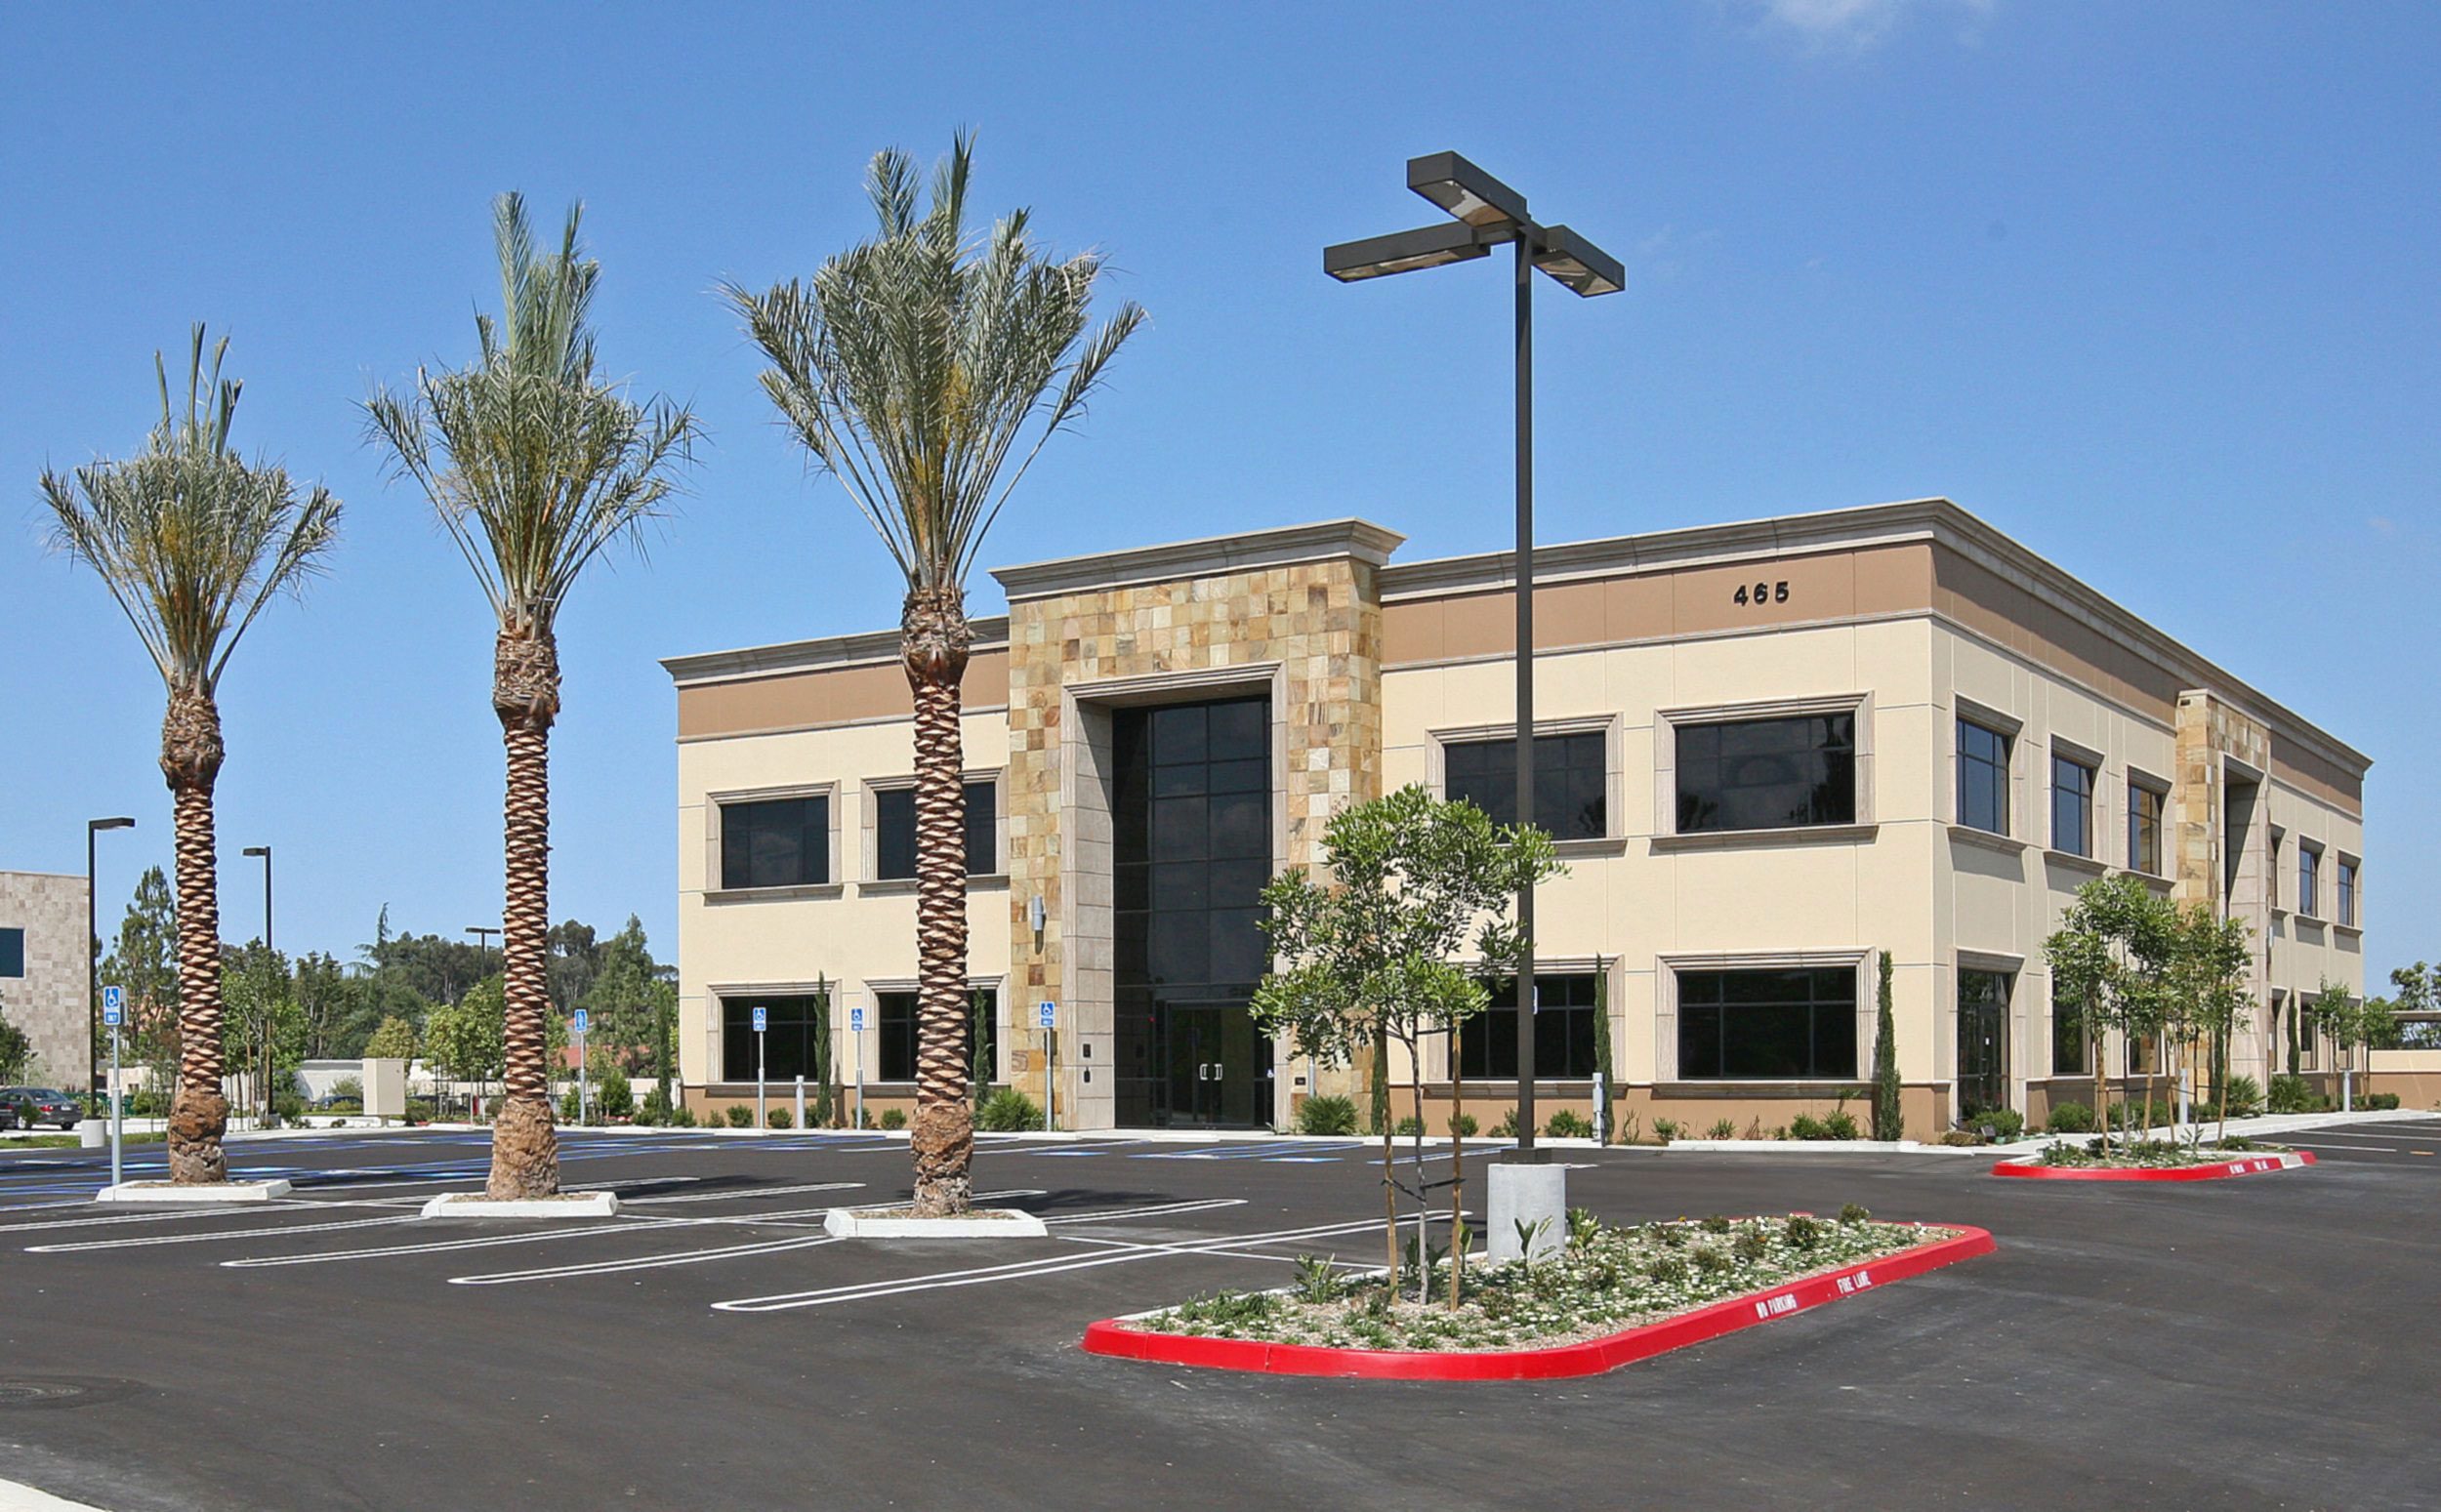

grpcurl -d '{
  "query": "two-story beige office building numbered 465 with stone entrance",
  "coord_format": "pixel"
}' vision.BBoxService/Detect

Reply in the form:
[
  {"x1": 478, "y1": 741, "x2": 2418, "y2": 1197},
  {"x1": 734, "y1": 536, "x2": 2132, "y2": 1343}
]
[{"x1": 664, "y1": 500, "x2": 2371, "y2": 1134}]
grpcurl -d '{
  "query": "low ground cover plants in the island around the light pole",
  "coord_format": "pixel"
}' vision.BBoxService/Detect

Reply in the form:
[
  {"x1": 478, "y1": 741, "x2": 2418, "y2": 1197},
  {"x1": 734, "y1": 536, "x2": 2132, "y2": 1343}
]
[{"x1": 1128, "y1": 1203, "x2": 1958, "y2": 1351}]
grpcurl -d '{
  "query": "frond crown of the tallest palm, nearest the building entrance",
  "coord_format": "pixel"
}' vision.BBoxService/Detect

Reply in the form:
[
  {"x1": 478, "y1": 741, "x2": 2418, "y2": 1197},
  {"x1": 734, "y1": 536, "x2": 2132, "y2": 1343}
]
[{"x1": 723, "y1": 132, "x2": 1145, "y2": 591}]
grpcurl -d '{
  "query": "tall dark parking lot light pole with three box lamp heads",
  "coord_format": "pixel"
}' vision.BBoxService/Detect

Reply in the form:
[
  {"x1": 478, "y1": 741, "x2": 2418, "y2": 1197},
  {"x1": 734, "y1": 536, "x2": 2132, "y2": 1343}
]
[{"x1": 1323, "y1": 151, "x2": 1629, "y2": 1159}]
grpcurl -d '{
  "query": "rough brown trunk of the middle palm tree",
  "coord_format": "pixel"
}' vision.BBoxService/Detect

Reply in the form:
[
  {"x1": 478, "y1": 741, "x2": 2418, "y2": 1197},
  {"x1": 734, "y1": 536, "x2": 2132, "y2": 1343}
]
[{"x1": 483, "y1": 627, "x2": 559, "y2": 1200}]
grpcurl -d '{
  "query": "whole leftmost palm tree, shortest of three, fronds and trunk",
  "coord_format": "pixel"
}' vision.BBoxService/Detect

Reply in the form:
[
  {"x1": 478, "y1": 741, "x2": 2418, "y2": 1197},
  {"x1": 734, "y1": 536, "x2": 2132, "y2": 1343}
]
[{"x1": 42, "y1": 324, "x2": 340, "y2": 1185}]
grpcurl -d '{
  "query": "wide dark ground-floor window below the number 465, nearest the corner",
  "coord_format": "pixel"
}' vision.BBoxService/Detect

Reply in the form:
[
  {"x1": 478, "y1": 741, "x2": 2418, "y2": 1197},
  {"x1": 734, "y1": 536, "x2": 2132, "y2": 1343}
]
[{"x1": 1679, "y1": 965, "x2": 1855, "y2": 1081}]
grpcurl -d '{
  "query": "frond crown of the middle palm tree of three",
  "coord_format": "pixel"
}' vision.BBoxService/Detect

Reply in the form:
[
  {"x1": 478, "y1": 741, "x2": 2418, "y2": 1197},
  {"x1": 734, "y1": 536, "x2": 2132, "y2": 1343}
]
[{"x1": 364, "y1": 192, "x2": 701, "y2": 632}]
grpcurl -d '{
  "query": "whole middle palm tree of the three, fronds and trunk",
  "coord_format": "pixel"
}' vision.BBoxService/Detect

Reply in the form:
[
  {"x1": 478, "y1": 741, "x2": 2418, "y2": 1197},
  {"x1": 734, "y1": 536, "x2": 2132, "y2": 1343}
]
[{"x1": 366, "y1": 195, "x2": 698, "y2": 1198}]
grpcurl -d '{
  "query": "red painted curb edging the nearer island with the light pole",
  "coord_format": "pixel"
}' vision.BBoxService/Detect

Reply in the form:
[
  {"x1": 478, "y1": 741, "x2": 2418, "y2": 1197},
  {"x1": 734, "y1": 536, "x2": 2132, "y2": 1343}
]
[{"x1": 1084, "y1": 1224, "x2": 1995, "y2": 1380}]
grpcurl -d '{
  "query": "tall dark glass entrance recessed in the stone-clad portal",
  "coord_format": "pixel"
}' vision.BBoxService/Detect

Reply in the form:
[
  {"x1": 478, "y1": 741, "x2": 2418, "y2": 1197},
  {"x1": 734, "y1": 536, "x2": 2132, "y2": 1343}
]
[{"x1": 1111, "y1": 698, "x2": 1272, "y2": 1129}]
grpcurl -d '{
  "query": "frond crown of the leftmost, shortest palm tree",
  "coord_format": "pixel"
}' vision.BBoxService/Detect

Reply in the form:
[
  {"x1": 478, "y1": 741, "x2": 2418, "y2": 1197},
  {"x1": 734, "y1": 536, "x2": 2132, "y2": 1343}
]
[{"x1": 42, "y1": 324, "x2": 340, "y2": 695}]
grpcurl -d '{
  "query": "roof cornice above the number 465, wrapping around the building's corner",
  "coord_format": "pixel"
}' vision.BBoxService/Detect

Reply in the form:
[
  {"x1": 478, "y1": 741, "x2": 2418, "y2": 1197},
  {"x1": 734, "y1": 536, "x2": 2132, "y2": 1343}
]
[{"x1": 1382, "y1": 498, "x2": 2373, "y2": 775}]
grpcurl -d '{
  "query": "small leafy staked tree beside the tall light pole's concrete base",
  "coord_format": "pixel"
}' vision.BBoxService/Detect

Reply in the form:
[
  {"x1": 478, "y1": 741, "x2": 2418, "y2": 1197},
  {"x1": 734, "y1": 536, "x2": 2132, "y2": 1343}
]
[{"x1": 1253, "y1": 785, "x2": 1562, "y2": 1305}]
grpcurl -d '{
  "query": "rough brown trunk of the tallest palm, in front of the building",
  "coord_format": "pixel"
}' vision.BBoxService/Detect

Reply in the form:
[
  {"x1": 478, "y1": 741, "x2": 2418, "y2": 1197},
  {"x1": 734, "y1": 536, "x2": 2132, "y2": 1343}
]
[{"x1": 901, "y1": 586, "x2": 974, "y2": 1217}]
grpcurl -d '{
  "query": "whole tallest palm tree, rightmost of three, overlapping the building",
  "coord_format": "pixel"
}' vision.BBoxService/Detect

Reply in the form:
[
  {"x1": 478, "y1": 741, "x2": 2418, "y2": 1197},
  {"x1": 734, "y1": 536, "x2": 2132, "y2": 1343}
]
[{"x1": 725, "y1": 132, "x2": 1145, "y2": 1214}]
